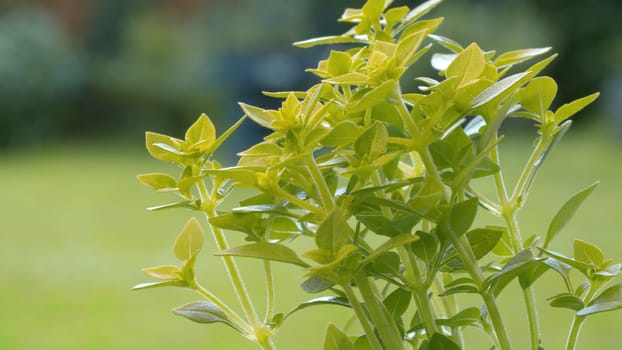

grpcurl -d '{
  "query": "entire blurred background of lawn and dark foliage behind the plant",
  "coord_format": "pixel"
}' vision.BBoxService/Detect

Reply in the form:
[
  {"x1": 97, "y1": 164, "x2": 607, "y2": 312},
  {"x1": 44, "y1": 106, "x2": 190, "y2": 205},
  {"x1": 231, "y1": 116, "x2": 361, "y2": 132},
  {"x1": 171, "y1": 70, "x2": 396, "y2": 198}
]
[{"x1": 0, "y1": 0, "x2": 622, "y2": 349}]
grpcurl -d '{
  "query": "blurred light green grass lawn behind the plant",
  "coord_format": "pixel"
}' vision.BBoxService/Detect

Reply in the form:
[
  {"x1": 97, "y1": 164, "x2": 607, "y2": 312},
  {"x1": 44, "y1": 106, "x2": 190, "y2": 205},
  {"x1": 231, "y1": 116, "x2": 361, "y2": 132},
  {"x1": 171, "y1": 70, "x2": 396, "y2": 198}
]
[{"x1": 0, "y1": 126, "x2": 622, "y2": 350}]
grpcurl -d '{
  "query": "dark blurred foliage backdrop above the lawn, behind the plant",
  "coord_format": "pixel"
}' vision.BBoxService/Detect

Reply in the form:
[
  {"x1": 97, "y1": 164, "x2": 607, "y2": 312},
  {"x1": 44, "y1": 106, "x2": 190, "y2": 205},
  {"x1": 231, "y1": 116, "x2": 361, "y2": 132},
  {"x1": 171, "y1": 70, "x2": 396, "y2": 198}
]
[{"x1": 0, "y1": 0, "x2": 622, "y2": 147}]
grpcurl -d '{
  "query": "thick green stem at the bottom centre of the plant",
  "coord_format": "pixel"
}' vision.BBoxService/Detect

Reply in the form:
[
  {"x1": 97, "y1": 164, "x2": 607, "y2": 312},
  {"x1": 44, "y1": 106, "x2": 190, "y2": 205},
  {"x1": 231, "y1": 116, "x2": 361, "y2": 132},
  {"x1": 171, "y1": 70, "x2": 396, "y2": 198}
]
[{"x1": 354, "y1": 272, "x2": 404, "y2": 350}]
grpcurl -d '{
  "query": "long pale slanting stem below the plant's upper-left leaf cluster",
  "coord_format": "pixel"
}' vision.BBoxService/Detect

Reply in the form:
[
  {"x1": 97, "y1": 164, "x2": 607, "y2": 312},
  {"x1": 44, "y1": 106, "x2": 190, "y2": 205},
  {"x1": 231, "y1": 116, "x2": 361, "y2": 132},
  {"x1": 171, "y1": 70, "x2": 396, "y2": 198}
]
[{"x1": 197, "y1": 181, "x2": 262, "y2": 333}]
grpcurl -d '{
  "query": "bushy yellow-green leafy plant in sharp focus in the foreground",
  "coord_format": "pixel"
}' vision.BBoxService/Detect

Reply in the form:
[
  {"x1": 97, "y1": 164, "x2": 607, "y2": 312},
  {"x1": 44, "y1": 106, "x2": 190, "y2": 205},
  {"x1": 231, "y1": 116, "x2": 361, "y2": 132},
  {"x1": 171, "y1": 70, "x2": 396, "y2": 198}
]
[{"x1": 135, "y1": 0, "x2": 622, "y2": 350}]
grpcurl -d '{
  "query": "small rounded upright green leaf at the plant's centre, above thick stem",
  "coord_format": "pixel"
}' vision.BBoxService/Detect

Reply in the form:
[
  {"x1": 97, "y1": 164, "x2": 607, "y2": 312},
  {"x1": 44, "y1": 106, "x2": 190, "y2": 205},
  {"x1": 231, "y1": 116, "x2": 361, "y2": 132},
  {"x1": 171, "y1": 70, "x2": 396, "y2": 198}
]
[{"x1": 315, "y1": 210, "x2": 352, "y2": 254}]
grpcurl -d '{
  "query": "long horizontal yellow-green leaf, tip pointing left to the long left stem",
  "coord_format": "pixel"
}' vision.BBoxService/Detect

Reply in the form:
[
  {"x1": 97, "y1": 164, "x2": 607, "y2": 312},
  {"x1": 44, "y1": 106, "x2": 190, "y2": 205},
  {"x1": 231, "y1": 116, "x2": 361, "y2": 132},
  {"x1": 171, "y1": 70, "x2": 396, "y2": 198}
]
[{"x1": 214, "y1": 242, "x2": 309, "y2": 267}]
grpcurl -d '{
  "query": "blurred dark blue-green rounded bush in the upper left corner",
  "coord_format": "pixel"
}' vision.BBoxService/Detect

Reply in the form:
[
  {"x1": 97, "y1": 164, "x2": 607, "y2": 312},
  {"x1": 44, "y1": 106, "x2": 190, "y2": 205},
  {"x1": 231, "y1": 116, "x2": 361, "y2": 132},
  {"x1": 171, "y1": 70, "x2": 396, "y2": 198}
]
[{"x1": 0, "y1": 7, "x2": 87, "y2": 146}]
